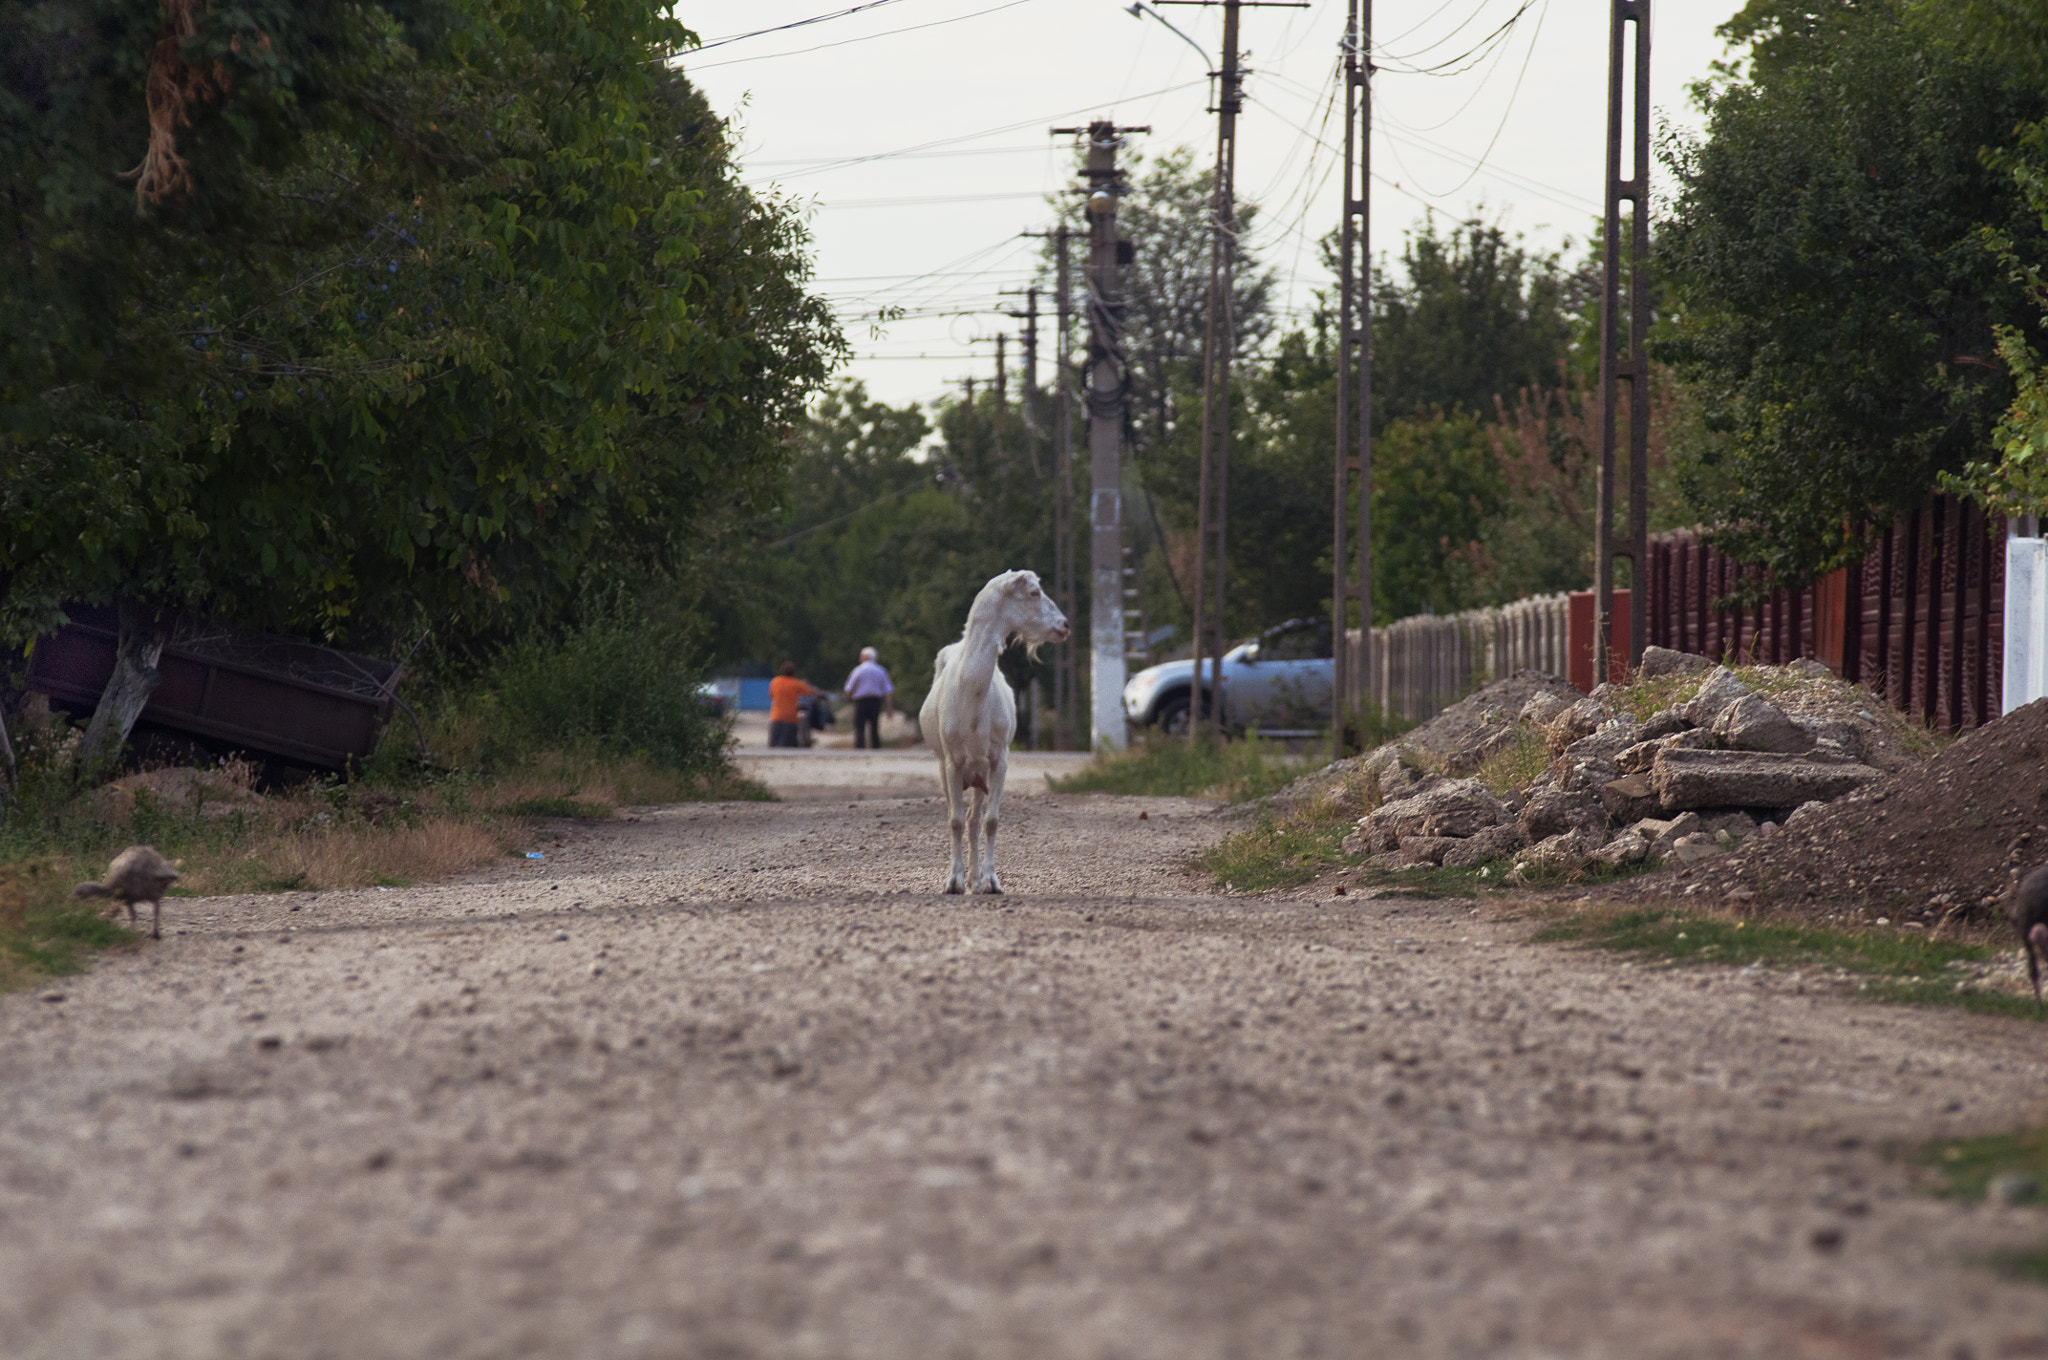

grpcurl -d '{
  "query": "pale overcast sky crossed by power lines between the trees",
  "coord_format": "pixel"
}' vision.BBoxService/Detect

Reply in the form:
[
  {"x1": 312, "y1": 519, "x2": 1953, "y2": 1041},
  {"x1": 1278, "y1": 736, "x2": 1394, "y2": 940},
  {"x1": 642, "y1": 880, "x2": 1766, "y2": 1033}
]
[{"x1": 676, "y1": 0, "x2": 1741, "y2": 413}]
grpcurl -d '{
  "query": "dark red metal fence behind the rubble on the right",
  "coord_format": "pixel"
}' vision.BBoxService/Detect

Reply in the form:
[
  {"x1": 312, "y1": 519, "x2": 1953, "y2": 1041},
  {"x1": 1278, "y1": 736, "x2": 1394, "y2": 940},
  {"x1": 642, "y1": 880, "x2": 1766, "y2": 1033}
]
[{"x1": 1647, "y1": 496, "x2": 2005, "y2": 731}]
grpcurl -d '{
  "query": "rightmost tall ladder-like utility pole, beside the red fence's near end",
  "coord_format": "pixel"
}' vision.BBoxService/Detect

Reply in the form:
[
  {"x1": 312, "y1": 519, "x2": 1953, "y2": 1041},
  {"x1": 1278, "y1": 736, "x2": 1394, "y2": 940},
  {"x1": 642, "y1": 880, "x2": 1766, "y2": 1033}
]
[{"x1": 1593, "y1": 0, "x2": 1651, "y2": 684}]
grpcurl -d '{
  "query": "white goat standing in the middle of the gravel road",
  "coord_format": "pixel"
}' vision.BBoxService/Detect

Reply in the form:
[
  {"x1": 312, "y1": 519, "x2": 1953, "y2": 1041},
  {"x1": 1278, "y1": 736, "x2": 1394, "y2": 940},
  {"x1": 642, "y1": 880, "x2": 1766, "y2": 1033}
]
[{"x1": 918, "y1": 571, "x2": 1067, "y2": 893}]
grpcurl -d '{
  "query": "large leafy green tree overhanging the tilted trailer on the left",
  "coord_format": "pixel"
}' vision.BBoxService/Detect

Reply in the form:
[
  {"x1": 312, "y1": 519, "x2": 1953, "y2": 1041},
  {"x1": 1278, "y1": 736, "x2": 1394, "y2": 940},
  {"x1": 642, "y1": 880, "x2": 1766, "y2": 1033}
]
[{"x1": 0, "y1": 0, "x2": 840, "y2": 782}]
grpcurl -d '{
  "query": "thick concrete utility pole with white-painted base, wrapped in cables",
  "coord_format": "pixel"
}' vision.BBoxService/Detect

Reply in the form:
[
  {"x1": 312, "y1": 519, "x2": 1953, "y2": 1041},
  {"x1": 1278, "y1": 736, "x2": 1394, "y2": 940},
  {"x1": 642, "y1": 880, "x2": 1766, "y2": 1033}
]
[{"x1": 1053, "y1": 123, "x2": 1151, "y2": 752}]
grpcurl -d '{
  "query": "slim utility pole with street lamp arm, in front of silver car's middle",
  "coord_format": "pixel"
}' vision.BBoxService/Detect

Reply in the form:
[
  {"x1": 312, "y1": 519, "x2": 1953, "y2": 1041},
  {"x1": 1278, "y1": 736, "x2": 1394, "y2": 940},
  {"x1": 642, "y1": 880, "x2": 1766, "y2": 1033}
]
[{"x1": 1155, "y1": 0, "x2": 1309, "y2": 739}]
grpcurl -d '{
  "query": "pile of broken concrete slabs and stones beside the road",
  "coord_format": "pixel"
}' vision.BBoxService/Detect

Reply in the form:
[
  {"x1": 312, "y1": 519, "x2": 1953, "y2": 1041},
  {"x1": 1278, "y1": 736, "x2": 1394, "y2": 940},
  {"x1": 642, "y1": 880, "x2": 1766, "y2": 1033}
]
[{"x1": 1343, "y1": 647, "x2": 1913, "y2": 877}]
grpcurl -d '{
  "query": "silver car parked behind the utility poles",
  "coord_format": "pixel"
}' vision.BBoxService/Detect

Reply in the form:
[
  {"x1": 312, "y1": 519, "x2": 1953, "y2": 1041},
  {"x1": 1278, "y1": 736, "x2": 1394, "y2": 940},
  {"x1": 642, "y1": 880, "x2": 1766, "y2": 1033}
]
[{"x1": 1124, "y1": 619, "x2": 1333, "y2": 737}]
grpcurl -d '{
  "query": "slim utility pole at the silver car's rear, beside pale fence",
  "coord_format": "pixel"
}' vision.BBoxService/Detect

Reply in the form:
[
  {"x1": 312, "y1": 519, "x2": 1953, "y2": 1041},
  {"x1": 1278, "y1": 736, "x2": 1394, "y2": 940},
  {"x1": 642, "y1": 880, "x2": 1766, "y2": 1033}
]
[{"x1": 1329, "y1": 0, "x2": 1372, "y2": 760}]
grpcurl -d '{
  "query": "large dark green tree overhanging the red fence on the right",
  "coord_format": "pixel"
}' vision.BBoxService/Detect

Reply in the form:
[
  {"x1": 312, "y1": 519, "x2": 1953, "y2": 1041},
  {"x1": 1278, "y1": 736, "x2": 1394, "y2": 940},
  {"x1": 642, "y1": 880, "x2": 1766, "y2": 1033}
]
[{"x1": 1653, "y1": 0, "x2": 2048, "y2": 588}]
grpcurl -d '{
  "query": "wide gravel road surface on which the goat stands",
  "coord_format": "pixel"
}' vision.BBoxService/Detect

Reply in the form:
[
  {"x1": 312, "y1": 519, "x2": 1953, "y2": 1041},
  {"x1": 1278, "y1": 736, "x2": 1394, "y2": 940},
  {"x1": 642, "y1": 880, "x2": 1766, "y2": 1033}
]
[{"x1": 0, "y1": 782, "x2": 2048, "y2": 1360}]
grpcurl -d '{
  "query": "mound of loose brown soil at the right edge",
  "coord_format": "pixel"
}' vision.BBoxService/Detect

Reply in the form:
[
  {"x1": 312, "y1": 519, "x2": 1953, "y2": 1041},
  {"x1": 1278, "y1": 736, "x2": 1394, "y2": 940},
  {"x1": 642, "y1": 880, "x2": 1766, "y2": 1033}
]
[{"x1": 1618, "y1": 698, "x2": 2048, "y2": 924}]
